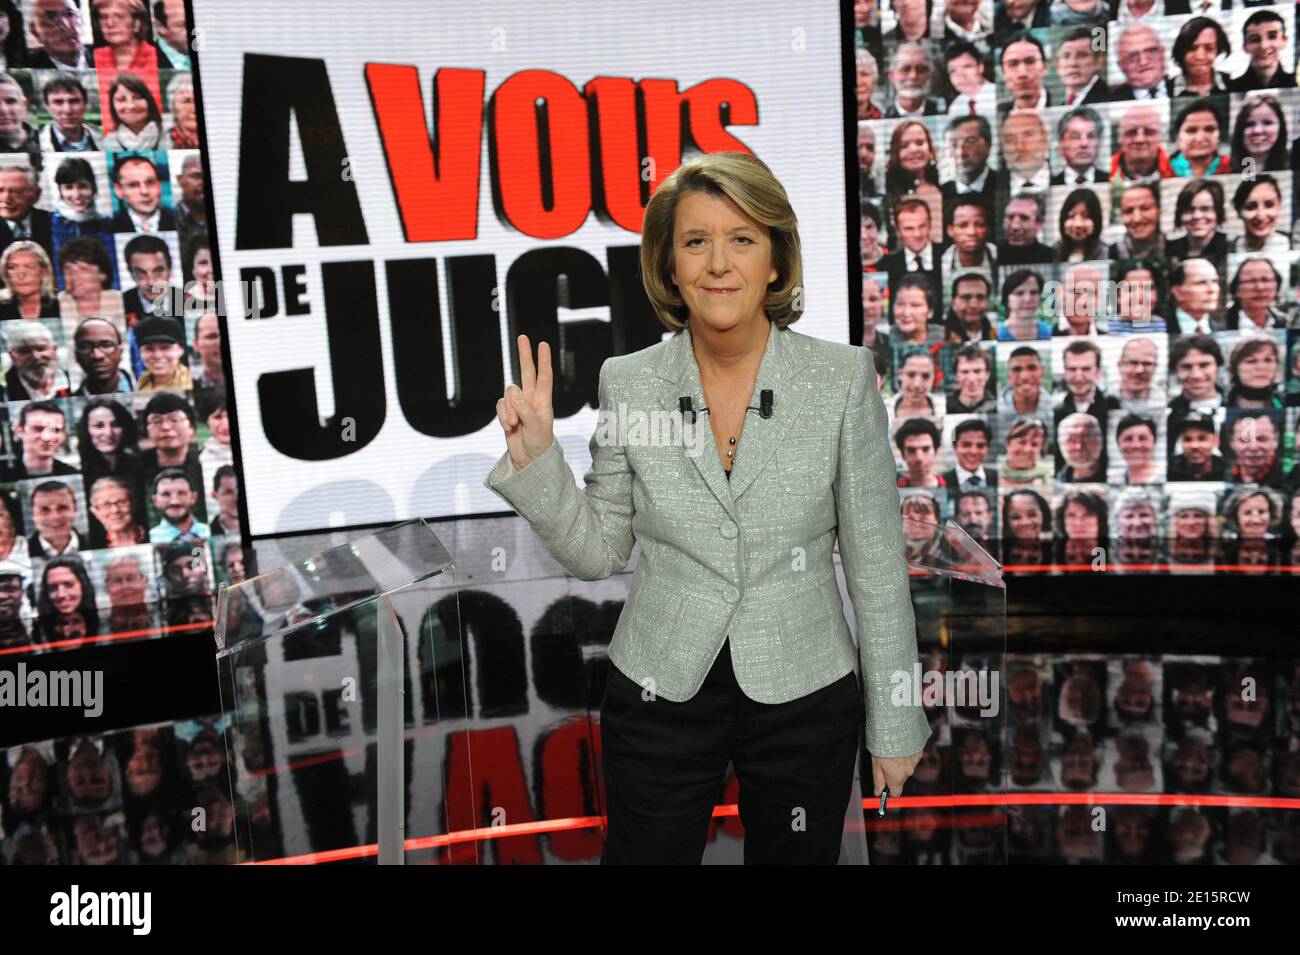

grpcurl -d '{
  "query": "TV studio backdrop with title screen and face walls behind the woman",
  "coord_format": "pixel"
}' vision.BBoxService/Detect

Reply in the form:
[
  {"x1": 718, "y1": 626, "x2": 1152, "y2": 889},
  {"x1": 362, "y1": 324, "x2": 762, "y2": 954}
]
[{"x1": 0, "y1": 0, "x2": 1300, "y2": 864}]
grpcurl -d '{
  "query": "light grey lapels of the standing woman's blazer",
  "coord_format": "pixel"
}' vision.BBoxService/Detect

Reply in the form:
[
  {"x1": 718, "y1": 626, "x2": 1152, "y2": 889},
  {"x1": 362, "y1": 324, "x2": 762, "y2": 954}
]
[{"x1": 657, "y1": 325, "x2": 803, "y2": 520}]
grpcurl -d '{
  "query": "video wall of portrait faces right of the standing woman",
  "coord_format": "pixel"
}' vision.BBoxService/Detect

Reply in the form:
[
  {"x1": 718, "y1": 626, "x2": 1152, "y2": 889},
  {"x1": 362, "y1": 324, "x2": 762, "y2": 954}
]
[{"x1": 854, "y1": 0, "x2": 1300, "y2": 573}]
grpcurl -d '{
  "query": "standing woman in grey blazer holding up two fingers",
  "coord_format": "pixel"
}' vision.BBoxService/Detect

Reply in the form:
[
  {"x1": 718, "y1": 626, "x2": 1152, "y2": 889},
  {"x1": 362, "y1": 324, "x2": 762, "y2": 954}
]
[{"x1": 485, "y1": 152, "x2": 932, "y2": 863}]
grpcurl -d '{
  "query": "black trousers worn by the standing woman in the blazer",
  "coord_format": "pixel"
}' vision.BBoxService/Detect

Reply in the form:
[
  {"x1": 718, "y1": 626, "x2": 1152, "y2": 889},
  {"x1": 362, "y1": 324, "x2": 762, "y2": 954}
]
[{"x1": 601, "y1": 639, "x2": 863, "y2": 865}]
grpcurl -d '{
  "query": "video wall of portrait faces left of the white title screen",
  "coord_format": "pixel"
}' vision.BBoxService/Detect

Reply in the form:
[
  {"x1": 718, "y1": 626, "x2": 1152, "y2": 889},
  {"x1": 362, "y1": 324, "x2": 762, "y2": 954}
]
[{"x1": 0, "y1": 0, "x2": 243, "y2": 663}]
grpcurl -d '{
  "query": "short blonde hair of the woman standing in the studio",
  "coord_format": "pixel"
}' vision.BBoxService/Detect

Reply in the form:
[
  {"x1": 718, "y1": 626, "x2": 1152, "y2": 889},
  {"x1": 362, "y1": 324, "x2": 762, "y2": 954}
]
[{"x1": 641, "y1": 152, "x2": 803, "y2": 331}]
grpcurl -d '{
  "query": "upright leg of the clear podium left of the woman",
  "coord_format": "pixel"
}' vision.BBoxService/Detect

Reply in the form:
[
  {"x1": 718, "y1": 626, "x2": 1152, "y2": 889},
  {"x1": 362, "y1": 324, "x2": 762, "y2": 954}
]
[{"x1": 376, "y1": 596, "x2": 406, "y2": 865}]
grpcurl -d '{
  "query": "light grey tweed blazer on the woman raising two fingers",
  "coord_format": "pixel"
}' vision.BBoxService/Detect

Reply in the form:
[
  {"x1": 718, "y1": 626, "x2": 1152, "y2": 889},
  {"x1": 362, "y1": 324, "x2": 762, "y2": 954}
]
[{"x1": 484, "y1": 325, "x2": 931, "y2": 756}]
